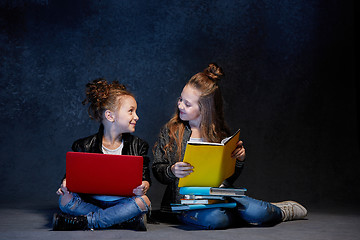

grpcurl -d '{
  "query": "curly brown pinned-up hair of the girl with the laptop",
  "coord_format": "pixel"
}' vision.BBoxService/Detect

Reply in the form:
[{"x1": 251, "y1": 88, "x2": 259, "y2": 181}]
[{"x1": 82, "y1": 78, "x2": 134, "y2": 122}]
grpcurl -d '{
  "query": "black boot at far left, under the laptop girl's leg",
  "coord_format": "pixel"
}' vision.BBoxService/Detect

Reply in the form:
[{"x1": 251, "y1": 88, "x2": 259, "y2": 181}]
[{"x1": 53, "y1": 213, "x2": 88, "y2": 231}]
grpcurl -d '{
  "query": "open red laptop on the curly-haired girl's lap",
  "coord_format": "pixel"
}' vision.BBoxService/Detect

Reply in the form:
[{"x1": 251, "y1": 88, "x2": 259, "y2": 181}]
[{"x1": 66, "y1": 152, "x2": 143, "y2": 196}]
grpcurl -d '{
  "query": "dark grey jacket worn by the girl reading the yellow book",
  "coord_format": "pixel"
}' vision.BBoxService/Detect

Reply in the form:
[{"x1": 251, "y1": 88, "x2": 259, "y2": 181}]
[{"x1": 152, "y1": 125, "x2": 243, "y2": 211}]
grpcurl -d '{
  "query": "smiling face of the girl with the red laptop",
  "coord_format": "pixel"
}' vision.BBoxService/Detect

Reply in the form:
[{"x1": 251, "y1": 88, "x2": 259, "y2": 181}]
[{"x1": 114, "y1": 96, "x2": 139, "y2": 133}]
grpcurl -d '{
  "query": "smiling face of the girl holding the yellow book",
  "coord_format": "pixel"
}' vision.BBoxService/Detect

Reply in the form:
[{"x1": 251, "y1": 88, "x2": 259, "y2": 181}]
[{"x1": 178, "y1": 85, "x2": 201, "y2": 127}]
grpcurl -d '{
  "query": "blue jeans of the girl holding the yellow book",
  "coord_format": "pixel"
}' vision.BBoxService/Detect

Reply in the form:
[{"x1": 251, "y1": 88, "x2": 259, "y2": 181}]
[{"x1": 178, "y1": 196, "x2": 282, "y2": 229}]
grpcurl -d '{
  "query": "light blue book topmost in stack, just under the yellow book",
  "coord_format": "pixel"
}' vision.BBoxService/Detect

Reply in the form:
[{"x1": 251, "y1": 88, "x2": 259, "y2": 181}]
[{"x1": 180, "y1": 187, "x2": 246, "y2": 197}]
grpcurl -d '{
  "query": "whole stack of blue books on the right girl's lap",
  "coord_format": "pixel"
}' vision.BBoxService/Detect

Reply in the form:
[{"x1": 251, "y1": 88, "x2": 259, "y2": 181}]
[{"x1": 171, "y1": 187, "x2": 246, "y2": 212}]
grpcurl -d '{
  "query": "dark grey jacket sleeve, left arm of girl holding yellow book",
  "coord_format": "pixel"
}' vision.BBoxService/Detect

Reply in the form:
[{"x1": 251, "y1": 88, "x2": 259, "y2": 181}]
[{"x1": 152, "y1": 128, "x2": 177, "y2": 185}]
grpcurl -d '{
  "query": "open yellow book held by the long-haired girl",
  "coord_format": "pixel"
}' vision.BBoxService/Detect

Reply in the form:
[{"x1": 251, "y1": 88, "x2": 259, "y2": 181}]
[{"x1": 179, "y1": 129, "x2": 240, "y2": 187}]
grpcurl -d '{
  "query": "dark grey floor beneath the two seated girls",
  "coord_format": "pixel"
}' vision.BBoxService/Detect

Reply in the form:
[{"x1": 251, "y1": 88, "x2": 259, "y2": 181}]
[{"x1": 0, "y1": 202, "x2": 360, "y2": 240}]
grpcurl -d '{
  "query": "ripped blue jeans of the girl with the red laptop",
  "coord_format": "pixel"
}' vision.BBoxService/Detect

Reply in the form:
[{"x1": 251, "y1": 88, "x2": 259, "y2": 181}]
[{"x1": 59, "y1": 193, "x2": 149, "y2": 229}]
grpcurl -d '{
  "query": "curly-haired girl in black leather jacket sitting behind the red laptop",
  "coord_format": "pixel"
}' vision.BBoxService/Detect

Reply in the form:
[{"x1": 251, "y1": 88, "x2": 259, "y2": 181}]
[{"x1": 53, "y1": 78, "x2": 151, "y2": 231}]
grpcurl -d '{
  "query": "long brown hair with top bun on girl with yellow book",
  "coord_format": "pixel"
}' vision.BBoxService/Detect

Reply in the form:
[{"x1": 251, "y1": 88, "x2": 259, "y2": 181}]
[{"x1": 164, "y1": 63, "x2": 230, "y2": 160}]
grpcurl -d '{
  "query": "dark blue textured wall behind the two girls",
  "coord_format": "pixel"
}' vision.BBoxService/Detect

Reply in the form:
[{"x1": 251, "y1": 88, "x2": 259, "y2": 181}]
[{"x1": 0, "y1": 0, "x2": 359, "y2": 206}]
